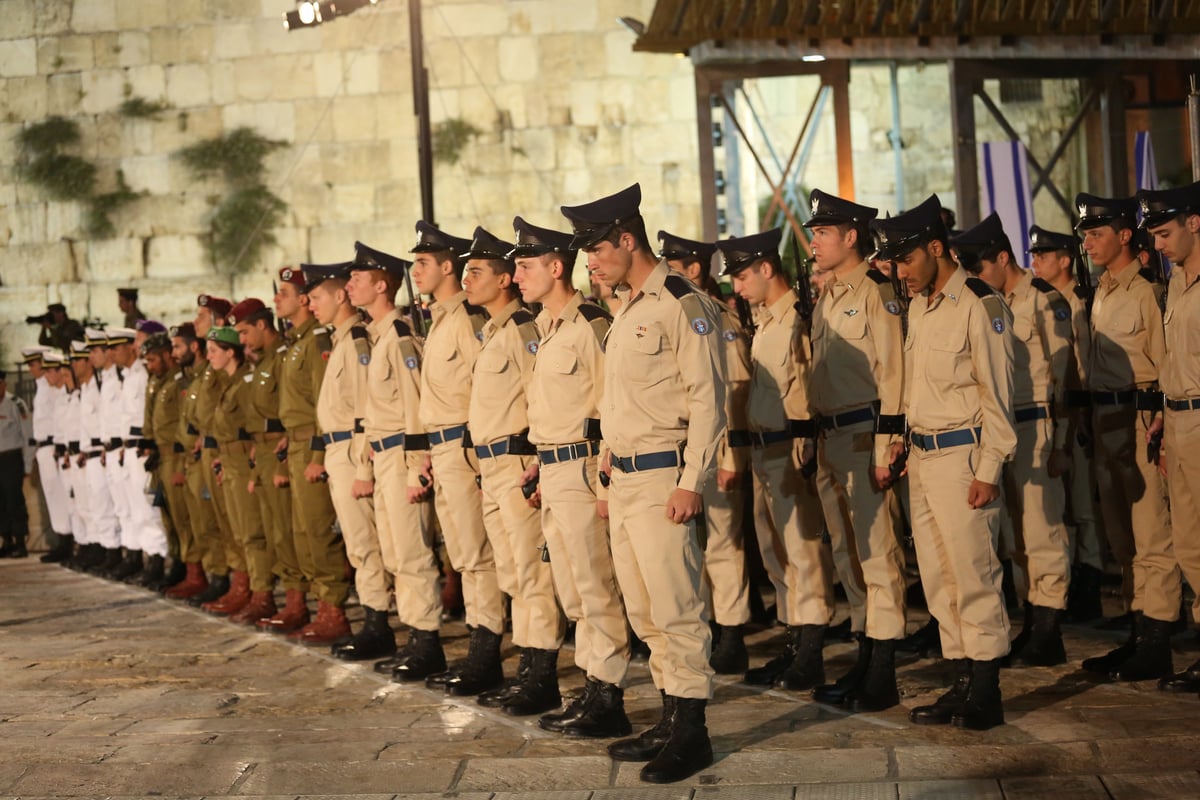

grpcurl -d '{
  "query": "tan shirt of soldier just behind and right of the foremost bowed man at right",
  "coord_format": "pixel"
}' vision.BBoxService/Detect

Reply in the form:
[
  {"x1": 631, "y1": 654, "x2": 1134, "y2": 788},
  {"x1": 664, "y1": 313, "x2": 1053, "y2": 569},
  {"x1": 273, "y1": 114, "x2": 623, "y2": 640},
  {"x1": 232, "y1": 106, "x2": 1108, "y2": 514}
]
[{"x1": 1004, "y1": 272, "x2": 1072, "y2": 450}]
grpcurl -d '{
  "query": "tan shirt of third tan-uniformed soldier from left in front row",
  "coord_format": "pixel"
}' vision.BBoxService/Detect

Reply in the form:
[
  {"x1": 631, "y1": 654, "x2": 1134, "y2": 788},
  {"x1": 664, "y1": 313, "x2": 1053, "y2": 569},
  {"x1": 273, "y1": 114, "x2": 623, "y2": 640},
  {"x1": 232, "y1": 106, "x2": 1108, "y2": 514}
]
[{"x1": 421, "y1": 291, "x2": 482, "y2": 431}]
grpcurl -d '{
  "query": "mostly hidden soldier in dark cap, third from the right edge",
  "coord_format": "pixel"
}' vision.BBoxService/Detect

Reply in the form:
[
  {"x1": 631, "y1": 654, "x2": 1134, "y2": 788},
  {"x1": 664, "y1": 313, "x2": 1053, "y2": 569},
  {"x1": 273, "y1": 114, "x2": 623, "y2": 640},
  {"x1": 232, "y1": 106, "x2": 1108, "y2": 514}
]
[{"x1": 1027, "y1": 225, "x2": 1104, "y2": 622}]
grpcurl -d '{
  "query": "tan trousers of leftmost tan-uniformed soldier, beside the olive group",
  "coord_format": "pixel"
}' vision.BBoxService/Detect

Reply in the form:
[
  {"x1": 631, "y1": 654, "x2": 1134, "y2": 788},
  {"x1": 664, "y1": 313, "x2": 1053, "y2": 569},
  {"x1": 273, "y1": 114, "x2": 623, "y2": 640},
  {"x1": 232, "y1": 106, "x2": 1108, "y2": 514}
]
[{"x1": 325, "y1": 441, "x2": 391, "y2": 612}]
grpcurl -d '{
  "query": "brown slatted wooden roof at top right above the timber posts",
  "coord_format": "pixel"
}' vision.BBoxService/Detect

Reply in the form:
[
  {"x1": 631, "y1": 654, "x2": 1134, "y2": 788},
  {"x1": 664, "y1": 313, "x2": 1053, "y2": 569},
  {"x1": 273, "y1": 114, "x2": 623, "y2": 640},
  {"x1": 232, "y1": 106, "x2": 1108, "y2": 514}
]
[{"x1": 634, "y1": 0, "x2": 1200, "y2": 61}]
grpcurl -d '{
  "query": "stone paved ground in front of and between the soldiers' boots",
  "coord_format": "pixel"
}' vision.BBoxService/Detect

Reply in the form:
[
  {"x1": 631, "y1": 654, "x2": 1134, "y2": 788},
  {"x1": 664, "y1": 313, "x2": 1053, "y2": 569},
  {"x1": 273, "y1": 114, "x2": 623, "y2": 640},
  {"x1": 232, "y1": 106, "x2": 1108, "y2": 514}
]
[{"x1": 0, "y1": 559, "x2": 1200, "y2": 800}]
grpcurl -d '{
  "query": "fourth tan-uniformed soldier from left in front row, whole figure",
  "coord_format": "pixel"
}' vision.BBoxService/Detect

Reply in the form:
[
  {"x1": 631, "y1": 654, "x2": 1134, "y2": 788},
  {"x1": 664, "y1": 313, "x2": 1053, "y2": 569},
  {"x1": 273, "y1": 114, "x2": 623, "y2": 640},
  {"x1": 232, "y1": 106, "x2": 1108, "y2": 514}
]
[{"x1": 462, "y1": 228, "x2": 564, "y2": 716}]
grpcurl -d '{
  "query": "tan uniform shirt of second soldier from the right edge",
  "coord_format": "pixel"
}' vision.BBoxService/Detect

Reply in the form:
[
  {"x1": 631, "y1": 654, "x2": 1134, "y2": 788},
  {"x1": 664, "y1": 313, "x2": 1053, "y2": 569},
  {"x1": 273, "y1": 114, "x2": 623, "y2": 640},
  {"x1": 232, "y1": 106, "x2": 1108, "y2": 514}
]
[{"x1": 1088, "y1": 261, "x2": 1166, "y2": 392}]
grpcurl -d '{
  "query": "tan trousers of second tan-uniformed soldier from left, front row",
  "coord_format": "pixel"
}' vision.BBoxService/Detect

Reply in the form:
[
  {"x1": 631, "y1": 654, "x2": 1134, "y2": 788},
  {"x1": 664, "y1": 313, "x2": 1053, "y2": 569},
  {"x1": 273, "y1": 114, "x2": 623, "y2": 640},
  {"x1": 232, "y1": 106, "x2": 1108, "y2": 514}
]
[{"x1": 374, "y1": 447, "x2": 442, "y2": 631}]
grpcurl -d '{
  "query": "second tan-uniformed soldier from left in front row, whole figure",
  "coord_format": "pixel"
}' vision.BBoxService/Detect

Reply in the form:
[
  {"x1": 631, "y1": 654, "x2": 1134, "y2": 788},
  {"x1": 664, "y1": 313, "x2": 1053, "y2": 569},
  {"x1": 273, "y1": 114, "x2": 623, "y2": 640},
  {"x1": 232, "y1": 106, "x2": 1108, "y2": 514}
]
[{"x1": 346, "y1": 242, "x2": 446, "y2": 681}]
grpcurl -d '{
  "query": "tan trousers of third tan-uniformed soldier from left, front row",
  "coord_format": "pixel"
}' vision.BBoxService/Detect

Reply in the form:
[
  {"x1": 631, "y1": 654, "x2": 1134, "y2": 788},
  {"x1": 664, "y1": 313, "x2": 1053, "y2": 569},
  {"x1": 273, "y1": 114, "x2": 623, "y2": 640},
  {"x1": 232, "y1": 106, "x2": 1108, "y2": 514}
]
[{"x1": 430, "y1": 440, "x2": 504, "y2": 633}]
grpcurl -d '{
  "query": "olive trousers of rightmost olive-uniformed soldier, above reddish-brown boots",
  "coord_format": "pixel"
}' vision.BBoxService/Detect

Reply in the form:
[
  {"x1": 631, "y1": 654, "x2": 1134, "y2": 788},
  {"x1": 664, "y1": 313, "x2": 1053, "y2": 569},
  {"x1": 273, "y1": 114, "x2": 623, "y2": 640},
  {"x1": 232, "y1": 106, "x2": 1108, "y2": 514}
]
[{"x1": 288, "y1": 435, "x2": 350, "y2": 608}]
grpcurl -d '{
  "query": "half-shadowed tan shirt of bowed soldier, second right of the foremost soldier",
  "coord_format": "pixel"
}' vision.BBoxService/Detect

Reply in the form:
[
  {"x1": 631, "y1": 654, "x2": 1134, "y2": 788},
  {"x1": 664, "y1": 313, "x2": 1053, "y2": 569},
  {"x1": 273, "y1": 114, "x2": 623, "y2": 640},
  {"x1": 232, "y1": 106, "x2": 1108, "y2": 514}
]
[{"x1": 746, "y1": 289, "x2": 812, "y2": 433}]
